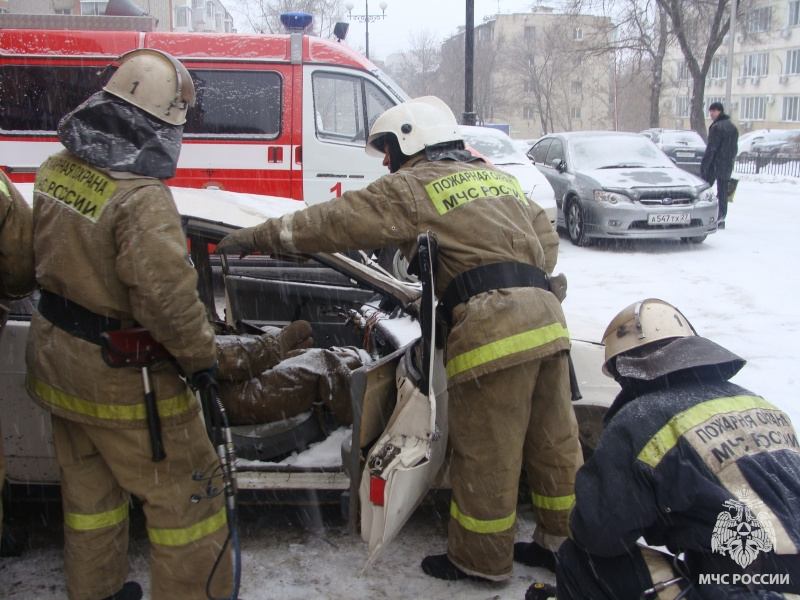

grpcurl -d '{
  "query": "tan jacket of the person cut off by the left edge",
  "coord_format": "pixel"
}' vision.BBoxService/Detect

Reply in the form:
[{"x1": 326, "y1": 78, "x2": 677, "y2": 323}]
[{"x1": 0, "y1": 171, "x2": 36, "y2": 299}]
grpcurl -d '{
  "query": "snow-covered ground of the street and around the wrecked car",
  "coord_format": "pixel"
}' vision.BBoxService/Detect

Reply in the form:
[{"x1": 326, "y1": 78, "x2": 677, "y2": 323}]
[{"x1": 0, "y1": 176, "x2": 800, "y2": 600}]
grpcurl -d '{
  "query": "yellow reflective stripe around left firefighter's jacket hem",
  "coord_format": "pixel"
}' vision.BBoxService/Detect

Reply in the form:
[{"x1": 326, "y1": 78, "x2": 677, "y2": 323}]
[{"x1": 28, "y1": 374, "x2": 196, "y2": 421}]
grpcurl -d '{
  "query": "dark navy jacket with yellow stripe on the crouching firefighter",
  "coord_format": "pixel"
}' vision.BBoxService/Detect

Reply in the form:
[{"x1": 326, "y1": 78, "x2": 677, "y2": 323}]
[{"x1": 570, "y1": 371, "x2": 800, "y2": 568}]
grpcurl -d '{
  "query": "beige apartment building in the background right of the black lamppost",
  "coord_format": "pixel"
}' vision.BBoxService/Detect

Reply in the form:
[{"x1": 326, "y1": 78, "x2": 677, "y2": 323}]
[{"x1": 442, "y1": 6, "x2": 614, "y2": 138}]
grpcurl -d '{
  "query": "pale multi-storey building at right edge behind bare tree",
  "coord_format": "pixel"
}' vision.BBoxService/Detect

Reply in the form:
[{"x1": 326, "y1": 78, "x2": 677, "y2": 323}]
[{"x1": 661, "y1": 0, "x2": 800, "y2": 133}]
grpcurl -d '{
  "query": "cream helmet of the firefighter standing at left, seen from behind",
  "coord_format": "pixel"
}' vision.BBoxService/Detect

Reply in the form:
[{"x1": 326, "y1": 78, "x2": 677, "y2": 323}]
[{"x1": 103, "y1": 48, "x2": 195, "y2": 125}]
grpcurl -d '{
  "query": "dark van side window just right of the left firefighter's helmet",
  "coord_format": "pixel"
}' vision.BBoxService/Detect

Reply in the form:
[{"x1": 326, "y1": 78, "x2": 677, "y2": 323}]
[{"x1": 183, "y1": 69, "x2": 283, "y2": 139}]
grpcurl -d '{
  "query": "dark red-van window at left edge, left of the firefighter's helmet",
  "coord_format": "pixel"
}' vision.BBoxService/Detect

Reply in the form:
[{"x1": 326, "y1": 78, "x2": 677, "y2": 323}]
[{"x1": 0, "y1": 65, "x2": 104, "y2": 135}]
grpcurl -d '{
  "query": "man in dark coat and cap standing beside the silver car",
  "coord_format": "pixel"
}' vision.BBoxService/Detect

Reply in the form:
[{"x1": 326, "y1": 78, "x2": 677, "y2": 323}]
[{"x1": 700, "y1": 102, "x2": 739, "y2": 229}]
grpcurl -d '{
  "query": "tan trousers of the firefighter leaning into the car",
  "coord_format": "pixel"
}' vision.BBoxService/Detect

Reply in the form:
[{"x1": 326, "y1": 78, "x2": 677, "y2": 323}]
[{"x1": 448, "y1": 352, "x2": 583, "y2": 581}]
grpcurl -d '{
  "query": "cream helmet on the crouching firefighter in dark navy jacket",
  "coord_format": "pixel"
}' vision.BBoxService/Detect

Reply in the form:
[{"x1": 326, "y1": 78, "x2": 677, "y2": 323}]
[{"x1": 603, "y1": 298, "x2": 697, "y2": 377}]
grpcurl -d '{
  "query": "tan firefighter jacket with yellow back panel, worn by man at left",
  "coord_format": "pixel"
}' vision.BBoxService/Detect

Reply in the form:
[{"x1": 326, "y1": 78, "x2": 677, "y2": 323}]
[{"x1": 26, "y1": 151, "x2": 216, "y2": 427}]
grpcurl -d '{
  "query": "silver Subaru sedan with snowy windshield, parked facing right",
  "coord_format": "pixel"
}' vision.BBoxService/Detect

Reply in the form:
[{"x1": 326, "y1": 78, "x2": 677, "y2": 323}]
[{"x1": 528, "y1": 131, "x2": 717, "y2": 246}]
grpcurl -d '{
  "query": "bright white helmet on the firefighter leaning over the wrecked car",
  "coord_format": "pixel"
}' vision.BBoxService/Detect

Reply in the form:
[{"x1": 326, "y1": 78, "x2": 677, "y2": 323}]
[{"x1": 366, "y1": 96, "x2": 464, "y2": 157}]
